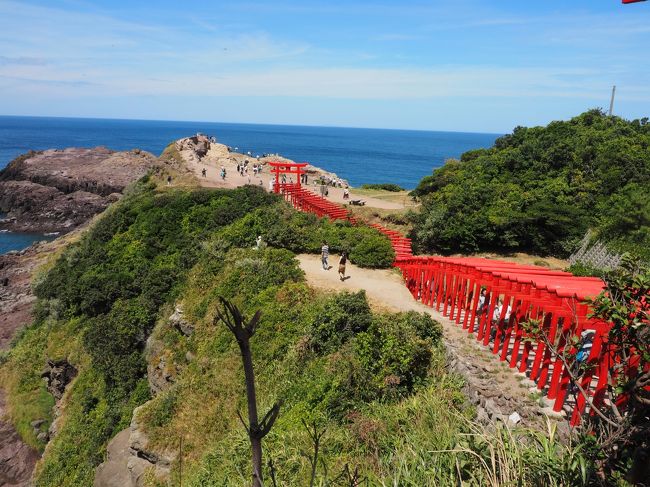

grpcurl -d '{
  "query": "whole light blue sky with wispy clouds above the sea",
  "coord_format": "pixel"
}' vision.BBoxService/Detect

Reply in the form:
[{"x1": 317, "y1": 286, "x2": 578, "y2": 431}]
[{"x1": 0, "y1": 0, "x2": 650, "y2": 133}]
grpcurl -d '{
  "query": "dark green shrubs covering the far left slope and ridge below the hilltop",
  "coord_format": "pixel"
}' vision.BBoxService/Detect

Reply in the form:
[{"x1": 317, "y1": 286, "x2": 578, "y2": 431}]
[{"x1": 0, "y1": 180, "x2": 393, "y2": 485}]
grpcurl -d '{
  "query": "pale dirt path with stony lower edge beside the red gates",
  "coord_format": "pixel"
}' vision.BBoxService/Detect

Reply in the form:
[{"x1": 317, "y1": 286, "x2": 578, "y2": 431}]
[{"x1": 297, "y1": 254, "x2": 558, "y2": 428}]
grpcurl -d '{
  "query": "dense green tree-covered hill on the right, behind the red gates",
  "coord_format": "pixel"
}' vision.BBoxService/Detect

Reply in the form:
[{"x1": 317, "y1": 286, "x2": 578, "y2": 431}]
[{"x1": 412, "y1": 110, "x2": 650, "y2": 259}]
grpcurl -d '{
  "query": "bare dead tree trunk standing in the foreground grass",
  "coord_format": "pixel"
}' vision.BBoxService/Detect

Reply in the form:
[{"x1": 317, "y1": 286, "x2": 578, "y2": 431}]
[{"x1": 214, "y1": 298, "x2": 280, "y2": 487}]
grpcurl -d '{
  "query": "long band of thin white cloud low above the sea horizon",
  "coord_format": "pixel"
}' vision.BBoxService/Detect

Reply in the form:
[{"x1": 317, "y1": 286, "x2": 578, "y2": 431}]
[{"x1": 0, "y1": 62, "x2": 650, "y2": 101}]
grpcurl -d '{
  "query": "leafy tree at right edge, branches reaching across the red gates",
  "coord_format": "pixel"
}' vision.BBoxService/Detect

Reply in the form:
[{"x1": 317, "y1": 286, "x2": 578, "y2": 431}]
[{"x1": 524, "y1": 254, "x2": 650, "y2": 485}]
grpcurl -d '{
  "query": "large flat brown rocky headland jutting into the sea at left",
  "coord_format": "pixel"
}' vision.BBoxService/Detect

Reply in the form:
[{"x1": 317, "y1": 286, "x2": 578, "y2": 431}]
[{"x1": 0, "y1": 147, "x2": 157, "y2": 233}]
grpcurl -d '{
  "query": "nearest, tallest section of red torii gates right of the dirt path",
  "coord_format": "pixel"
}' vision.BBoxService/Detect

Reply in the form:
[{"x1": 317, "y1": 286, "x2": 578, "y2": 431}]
[{"x1": 397, "y1": 257, "x2": 610, "y2": 425}]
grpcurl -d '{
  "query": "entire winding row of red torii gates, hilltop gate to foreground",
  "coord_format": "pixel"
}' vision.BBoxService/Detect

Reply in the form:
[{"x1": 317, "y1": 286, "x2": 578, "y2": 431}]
[{"x1": 270, "y1": 162, "x2": 640, "y2": 425}]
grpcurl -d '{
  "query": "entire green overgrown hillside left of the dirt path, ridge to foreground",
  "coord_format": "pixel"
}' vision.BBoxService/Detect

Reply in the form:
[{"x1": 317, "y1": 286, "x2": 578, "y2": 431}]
[{"x1": 0, "y1": 181, "x2": 591, "y2": 487}]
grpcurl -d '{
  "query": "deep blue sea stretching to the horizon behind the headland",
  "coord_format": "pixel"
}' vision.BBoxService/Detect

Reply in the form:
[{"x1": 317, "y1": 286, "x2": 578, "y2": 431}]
[{"x1": 0, "y1": 116, "x2": 501, "y2": 253}]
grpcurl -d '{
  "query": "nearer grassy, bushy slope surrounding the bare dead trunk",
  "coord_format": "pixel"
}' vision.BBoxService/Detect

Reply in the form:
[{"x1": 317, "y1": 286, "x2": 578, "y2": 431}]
[{"x1": 138, "y1": 241, "x2": 588, "y2": 486}]
